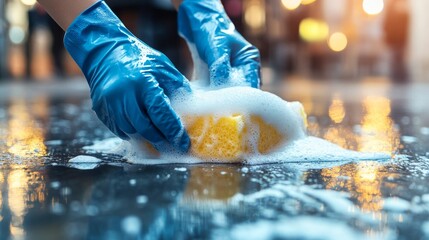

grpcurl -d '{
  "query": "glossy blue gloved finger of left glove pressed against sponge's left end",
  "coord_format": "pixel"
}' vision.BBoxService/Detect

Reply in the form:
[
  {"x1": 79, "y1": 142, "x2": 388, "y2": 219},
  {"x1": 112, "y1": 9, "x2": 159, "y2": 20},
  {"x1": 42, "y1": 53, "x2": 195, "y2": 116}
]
[{"x1": 143, "y1": 87, "x2": 190, "y2": 152}]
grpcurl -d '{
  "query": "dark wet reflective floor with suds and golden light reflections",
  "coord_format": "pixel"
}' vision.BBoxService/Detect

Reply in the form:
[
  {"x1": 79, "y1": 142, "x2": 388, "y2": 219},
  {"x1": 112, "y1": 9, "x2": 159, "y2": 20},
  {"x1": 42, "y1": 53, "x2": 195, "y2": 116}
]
[{"x1": 0, "y1": 78, "x2": 429, "y2": 239}]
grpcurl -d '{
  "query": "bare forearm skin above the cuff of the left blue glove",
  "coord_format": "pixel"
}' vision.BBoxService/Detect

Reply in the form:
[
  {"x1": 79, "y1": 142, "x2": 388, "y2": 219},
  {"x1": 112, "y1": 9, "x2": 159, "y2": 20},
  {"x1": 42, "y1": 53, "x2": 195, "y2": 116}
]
[{"x1": 38, "y1": 0, "x2": 98, "y2": 30}]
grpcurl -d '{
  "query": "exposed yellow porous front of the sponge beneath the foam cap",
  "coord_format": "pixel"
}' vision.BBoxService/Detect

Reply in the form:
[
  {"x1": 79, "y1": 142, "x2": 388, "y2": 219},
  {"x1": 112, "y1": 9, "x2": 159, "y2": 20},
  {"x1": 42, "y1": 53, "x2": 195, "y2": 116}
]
[{"x1": 183, "y1": 114, "x2": 286, "y2": 162}]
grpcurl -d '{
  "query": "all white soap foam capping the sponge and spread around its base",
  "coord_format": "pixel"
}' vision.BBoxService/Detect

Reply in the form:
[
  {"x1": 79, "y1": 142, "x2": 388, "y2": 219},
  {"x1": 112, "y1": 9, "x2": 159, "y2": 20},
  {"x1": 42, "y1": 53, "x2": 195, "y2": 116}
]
[{"x1": 86, "y1": 87, "x2": 391, "y2": 164}]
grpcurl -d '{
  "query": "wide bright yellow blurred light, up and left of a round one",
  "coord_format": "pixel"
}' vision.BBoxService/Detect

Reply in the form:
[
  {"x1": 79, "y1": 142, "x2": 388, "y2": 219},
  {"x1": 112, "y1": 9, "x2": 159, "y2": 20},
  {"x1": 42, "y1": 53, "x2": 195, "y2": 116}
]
[{"x1": 299, "y1": 18, "x2": 329, "y2": 42}]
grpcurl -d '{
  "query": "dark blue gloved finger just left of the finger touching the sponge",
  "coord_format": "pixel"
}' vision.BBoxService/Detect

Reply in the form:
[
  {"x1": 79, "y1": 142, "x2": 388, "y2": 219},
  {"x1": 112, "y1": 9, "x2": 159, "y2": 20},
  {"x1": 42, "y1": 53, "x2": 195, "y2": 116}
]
[{"x1": 125, "y1": 99, "x2": 165, "y2": 145}]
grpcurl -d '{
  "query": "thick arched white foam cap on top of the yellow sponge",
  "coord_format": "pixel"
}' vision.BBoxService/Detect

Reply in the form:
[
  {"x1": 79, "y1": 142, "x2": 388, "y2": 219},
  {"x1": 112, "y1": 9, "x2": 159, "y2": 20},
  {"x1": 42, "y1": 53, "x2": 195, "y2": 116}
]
[{"x1": 172, "y1": 87, "x2": 305, "y2": 143}]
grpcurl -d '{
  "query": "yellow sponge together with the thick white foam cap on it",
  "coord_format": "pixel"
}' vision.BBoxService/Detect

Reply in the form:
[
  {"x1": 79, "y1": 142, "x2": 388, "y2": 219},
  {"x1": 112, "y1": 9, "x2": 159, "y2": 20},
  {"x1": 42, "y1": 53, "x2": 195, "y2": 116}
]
[{"x1": 172, "y1": 87, "x2": 305, "y2": 162}]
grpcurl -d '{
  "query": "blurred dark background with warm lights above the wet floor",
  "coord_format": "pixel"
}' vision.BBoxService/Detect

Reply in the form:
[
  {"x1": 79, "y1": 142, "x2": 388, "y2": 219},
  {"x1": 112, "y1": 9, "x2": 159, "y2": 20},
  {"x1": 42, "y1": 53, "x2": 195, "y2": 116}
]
[{"x1": 0, "y1": 0, "x2": 429, "y2": 83}]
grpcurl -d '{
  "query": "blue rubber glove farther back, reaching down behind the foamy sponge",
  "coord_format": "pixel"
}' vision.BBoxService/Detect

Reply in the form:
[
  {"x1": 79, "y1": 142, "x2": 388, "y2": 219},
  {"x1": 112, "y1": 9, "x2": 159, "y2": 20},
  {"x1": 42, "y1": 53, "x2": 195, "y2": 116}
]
[{"x1": 178, "y1": 0, "x2": 260, "y2": 88}]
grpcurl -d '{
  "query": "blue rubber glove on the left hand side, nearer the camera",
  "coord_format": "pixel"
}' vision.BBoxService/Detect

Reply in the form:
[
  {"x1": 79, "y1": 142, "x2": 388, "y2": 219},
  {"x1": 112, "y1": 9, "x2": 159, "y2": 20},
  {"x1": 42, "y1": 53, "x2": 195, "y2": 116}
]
[{"x1": 64, "y1": 1, "x2": 190, "y2": 151}]
